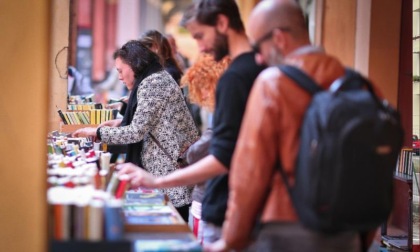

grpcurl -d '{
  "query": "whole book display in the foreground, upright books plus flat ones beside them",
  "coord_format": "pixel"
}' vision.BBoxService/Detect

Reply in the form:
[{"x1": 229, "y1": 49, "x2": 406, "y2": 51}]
[{"x1": 47, "y1": 132, "x2": 201, "y2": 252}]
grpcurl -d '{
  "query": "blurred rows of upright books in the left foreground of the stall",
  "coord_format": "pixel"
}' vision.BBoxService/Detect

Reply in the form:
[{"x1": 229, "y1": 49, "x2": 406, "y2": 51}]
[{"x1": 47, "y1": 132, "x2": 128, "y2": 241}]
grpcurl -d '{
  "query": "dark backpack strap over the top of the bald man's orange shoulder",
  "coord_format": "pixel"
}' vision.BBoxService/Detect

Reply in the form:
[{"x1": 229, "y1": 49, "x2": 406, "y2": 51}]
[{"x1": 278, "y1": 65, "x2": 322, "y2": 95}]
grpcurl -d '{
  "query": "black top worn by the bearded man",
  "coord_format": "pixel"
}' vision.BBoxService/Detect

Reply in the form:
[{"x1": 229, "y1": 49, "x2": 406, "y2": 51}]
[{"x1": 201, "y1": 52, "x2": 264, "y2": 226}]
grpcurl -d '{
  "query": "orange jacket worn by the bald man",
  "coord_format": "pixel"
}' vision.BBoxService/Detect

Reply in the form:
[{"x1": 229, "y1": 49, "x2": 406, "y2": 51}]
[{"x1": 223, "y1": 47, "x2": 344, "y2": 248}]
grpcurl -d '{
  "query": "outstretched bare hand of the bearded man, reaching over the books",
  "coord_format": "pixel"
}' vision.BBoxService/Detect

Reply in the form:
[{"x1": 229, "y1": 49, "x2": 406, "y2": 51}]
[{"x1": 116, "y1": 163, "x2": 158, "y2": 188}]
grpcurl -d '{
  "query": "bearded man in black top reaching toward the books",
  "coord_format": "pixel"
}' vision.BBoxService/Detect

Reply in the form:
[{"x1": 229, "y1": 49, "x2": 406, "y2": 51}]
[{"x1": 118, "y1": 0, "x2": 263, "y2": 243}]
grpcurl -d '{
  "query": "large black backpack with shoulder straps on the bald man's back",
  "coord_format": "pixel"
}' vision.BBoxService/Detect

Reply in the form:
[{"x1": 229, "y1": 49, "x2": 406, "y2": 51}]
[{"x1": 279, "y1": 65, "x2": 404, "y2": 233}]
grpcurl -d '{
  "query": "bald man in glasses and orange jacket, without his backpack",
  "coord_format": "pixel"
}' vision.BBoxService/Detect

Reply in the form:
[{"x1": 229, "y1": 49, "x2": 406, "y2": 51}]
[{"x1": 206, "y1": 0, "x2": 368, "y2": 252}]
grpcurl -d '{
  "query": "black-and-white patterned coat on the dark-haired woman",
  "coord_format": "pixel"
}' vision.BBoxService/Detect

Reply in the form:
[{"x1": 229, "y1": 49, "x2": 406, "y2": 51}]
[{"x1": 99, "y1": 70, "x2": 198, "y2": 207}]
